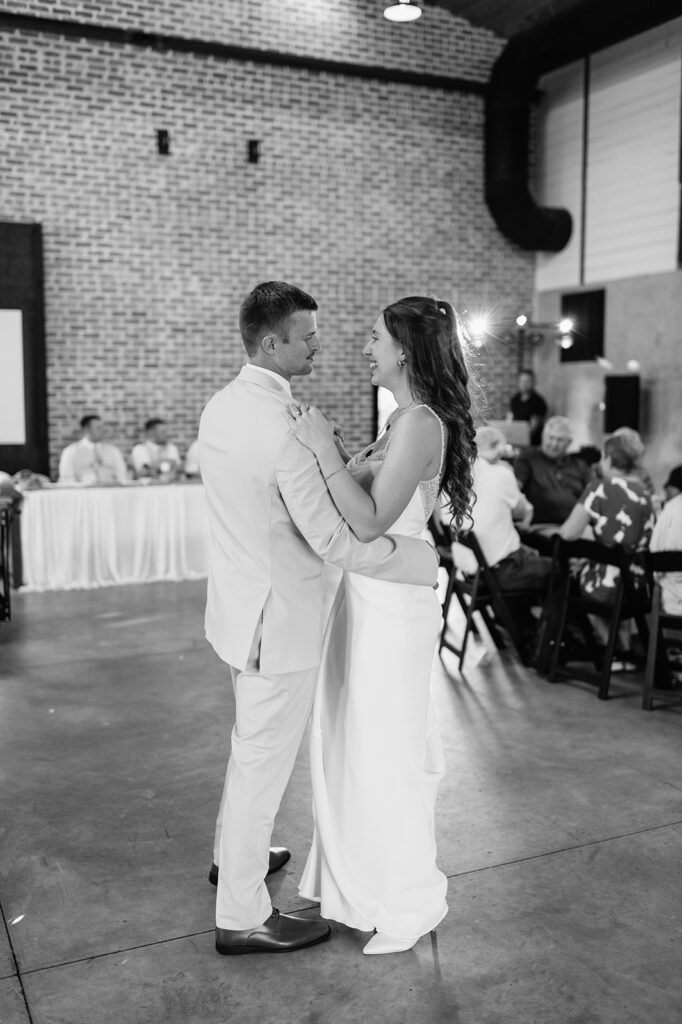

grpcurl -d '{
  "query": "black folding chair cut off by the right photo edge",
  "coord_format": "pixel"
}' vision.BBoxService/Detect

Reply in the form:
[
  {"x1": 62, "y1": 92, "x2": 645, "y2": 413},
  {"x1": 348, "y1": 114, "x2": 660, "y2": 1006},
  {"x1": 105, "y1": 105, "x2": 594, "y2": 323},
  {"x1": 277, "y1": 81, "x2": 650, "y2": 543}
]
[{"x1": 642, "y1": 551, "x2": 682, "y2": 711}]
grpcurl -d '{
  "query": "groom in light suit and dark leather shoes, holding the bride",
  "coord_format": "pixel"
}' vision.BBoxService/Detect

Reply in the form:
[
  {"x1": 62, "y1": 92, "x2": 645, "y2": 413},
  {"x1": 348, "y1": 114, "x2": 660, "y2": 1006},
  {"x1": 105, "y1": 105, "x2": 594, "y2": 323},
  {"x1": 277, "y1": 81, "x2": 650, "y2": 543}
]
[{"x1": 199, "y1": 282, "x2": 437, "y2": 953}]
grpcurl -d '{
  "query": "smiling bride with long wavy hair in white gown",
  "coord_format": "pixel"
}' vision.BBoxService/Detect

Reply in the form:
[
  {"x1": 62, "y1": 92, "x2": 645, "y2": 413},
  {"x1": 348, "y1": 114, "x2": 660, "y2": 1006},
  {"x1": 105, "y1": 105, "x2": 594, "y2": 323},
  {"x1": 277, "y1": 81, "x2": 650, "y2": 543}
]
[{"x1": 289, "y1": 297, "x2": 475, "y2": 953}]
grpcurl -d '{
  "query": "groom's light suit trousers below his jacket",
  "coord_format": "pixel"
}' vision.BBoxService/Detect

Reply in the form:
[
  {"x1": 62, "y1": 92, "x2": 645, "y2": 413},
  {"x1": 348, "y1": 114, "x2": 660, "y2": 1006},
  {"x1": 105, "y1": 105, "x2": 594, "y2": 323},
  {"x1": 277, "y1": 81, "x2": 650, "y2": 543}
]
[{"x1": 213, "y1": 644, "x2": 318, "y2": 930}]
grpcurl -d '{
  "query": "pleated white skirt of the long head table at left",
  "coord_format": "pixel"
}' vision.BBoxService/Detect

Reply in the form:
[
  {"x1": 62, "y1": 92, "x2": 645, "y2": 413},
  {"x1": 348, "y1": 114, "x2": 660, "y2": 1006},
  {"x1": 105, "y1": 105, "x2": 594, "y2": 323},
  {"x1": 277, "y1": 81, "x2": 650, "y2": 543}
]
[{"x1": 22, "y1": 483, "x2": 209, "y2": 591}]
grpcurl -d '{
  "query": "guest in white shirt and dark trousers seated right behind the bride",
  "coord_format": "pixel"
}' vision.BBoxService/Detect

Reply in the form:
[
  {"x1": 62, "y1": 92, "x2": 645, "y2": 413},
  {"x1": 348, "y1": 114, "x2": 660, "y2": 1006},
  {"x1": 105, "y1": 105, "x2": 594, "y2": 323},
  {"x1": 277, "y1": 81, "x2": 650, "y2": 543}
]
[{"x1": 454, "y1": 427, "x2": 552, "y2": 590}]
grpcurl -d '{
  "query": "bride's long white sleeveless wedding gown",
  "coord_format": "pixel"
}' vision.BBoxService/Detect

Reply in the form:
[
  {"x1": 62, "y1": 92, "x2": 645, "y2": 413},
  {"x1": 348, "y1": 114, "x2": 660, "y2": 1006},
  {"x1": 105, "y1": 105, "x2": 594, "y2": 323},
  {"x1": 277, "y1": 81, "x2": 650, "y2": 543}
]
[{"x1": 299, "y1": 414, "x2": 447, "y2": 936}]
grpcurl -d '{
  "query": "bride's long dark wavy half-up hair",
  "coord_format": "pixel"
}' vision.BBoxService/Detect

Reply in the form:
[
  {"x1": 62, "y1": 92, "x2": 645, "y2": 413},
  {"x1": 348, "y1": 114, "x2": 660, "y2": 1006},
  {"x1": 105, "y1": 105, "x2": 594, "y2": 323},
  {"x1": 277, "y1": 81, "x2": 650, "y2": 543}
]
[{"x1": 383, "y1": 296, "x2": 476, "y2": 535}]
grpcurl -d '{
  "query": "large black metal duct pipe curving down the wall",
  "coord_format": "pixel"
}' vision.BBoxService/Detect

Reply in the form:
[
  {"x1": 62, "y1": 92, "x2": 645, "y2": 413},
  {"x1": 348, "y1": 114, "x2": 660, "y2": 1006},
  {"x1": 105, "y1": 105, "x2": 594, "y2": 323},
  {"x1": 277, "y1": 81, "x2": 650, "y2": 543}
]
[{"x1": 485, "y1": 0, "x2": 682, "y2": 252}]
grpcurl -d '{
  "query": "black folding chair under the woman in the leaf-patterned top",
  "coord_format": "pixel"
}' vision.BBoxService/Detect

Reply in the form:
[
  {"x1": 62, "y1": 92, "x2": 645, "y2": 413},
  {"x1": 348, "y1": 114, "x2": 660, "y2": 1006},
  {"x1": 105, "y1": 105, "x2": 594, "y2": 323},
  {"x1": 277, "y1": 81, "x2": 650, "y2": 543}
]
[{"x1": 549, "y1": 541, "x2": 648, "y2": 700}]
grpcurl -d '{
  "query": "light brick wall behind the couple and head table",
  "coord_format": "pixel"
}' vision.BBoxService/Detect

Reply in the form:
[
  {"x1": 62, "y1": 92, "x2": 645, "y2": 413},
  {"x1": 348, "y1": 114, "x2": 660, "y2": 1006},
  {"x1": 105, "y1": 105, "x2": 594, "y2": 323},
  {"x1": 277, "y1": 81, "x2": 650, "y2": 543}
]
[{"x1": 0, "y1": 0, "x2": 532, "y2": 471}]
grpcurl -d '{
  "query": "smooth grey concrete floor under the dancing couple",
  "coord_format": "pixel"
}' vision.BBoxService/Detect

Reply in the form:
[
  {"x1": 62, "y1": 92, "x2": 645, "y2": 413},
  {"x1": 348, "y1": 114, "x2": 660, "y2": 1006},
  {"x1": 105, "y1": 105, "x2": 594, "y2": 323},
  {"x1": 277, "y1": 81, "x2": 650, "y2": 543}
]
[{"x1": 0, "y1": 584, "x2": 682, "y2": 1024}]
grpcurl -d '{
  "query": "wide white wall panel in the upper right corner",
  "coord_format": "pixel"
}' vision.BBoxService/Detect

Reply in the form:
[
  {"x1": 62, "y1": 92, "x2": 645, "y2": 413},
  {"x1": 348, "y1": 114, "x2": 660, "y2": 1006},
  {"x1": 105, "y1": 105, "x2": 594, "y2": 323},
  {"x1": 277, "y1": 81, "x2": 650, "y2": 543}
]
[{"x1": 585, "y1": 18, "x2": 682, "y2": 284}]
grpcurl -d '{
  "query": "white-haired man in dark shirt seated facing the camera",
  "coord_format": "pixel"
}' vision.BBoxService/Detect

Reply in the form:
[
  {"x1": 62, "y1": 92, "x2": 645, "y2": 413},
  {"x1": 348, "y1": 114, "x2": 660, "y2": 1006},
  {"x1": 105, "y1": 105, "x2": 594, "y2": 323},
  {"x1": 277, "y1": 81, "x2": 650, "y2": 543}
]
[{"x1": 514, "y1": 416, "x2": 591, "y2": 524}]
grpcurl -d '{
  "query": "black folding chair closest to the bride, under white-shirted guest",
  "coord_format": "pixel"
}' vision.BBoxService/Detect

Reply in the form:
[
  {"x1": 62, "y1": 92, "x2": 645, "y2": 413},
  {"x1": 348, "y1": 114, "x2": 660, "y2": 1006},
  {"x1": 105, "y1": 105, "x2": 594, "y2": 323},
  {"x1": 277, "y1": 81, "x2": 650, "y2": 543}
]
[{"x1": 438, "y1": 530, "x2": 539, "y2": 671}]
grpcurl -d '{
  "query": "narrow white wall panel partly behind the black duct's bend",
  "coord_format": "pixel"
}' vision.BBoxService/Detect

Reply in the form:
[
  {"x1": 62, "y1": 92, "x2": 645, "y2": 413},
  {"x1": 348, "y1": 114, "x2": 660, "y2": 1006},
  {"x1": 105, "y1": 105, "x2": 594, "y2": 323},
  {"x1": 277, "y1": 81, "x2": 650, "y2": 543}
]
[{"x1": 536, "y1": 60, "x2": 584, "y2": 291}]
